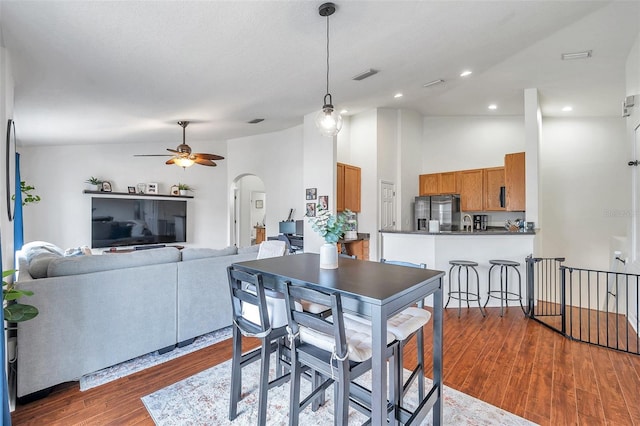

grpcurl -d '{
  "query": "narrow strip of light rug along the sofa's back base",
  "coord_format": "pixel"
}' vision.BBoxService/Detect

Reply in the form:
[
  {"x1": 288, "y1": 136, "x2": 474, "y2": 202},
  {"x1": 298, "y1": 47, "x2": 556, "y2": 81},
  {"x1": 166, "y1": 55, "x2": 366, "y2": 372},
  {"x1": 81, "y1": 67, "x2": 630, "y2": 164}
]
[{"x1": 80, "y1": 327, "x2": 231, "y2": 391}]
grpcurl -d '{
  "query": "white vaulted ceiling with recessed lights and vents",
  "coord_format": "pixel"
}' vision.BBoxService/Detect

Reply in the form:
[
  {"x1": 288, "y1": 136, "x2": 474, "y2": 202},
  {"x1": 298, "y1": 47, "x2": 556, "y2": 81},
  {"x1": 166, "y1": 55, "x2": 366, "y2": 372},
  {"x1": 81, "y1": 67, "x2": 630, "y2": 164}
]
[{"x1": 0, "y1": 0, "x2": 640, "y2": 148}]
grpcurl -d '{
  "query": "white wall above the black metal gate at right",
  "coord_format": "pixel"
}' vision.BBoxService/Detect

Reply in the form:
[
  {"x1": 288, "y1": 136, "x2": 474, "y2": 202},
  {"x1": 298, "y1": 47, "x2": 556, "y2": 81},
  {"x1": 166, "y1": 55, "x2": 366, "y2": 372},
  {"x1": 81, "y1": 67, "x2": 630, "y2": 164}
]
[{"x1": 540, "y1": 117, "x2": 631, "y2": 270}]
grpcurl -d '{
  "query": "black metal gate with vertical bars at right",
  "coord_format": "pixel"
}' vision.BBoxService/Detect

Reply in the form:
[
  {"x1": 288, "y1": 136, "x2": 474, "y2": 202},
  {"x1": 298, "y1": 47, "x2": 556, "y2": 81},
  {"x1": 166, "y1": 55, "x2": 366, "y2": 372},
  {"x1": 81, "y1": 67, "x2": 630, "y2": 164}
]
[{"x1": 527, "y1": 256, "x2": 640, "y2": 354}]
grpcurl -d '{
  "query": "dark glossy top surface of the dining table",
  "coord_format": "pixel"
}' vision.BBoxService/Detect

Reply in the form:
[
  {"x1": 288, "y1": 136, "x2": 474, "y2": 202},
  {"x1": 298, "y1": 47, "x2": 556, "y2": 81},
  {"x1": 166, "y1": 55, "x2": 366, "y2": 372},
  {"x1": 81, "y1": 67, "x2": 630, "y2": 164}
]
[{"x1": 234, "y1": 253, "x2": 444, "y2": 305}]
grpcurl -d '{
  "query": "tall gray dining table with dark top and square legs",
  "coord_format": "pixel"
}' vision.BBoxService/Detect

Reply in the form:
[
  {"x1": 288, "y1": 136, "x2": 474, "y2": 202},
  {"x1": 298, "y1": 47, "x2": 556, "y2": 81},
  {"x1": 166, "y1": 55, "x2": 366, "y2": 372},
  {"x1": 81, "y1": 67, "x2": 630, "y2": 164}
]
[{"x1": 233, "y1": 253, "x2": 444, "y2": 426}]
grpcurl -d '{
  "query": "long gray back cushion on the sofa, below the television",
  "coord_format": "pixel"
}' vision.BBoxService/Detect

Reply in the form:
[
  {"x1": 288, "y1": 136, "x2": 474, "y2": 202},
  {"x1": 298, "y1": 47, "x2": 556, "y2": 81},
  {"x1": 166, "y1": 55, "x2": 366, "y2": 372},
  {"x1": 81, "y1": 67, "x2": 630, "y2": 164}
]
[{"x1": 47, "y1": 247, "x2": 180, "y2": 277}]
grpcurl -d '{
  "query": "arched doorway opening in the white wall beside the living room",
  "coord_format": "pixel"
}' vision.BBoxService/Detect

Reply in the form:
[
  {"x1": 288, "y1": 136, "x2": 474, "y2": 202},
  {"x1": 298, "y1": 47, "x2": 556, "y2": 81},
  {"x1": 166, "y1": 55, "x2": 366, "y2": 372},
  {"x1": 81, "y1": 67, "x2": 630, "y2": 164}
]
[{"x1": 231, "y1": 174, "x2": 267, "y2": 247}]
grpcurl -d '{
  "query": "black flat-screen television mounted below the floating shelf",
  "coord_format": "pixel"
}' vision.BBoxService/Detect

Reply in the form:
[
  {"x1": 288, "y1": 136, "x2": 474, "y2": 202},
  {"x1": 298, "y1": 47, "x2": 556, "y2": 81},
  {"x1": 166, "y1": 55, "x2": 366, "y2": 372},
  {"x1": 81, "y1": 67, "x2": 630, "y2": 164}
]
[{"x1": 91, "y1": 197, "x2": 187, "y2": 248}]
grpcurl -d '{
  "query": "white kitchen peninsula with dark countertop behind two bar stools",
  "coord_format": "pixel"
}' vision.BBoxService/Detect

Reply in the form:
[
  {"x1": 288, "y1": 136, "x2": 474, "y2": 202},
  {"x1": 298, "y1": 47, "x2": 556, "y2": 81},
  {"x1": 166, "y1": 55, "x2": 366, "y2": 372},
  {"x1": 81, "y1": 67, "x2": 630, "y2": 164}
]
[{"x1": 380, "y1": 228, "x2": 536, "y2": 308}]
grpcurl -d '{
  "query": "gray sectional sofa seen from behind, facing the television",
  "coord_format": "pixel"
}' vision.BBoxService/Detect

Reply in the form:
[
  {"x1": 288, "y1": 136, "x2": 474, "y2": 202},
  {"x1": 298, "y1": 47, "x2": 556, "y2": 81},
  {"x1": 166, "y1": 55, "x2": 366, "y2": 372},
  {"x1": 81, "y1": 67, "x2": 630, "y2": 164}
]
[{"x1": 17, "y1": 243, "x2": 258, "y2": 397}]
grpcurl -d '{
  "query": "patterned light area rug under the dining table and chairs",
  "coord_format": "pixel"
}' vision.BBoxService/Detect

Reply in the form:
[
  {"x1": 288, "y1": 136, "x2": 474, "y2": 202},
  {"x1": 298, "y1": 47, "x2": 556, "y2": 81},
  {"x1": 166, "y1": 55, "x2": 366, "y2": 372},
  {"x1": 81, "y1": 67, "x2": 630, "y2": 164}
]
[{"x1": 142, "y1": 361, "x2": 535, "y2": 426}]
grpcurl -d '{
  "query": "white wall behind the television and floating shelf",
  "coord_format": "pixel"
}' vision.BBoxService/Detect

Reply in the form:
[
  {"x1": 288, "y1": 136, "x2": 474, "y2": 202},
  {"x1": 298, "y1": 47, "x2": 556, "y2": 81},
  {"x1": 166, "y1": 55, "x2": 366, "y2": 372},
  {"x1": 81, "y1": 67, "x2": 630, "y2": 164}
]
[{"x1": 16, "y1": 139, "x2": 228, "y2": 248}]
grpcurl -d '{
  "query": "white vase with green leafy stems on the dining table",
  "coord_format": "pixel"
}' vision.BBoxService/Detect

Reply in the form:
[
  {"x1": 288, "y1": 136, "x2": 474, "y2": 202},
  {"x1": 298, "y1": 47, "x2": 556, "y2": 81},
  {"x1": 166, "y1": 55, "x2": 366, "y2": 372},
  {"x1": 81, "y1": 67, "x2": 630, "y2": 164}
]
[{"x1": 308, "y1": 204, "x2": 351, "y2": 269}]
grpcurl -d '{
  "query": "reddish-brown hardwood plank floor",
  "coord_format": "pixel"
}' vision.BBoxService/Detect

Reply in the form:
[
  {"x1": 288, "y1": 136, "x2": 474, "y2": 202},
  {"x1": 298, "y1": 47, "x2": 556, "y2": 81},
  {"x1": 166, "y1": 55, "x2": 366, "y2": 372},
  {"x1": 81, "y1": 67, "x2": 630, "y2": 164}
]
[{"x1": 12, "y1": 308, "x2": 640, "y2": 425}]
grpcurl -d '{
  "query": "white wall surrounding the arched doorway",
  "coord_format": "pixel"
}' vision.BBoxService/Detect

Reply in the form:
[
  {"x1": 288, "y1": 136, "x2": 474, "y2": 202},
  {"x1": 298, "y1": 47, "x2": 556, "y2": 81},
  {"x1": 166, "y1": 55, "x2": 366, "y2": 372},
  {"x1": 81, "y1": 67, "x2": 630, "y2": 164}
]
[{"x1": 225, "y1": 125, "x2": 306, "y2": 241}]
